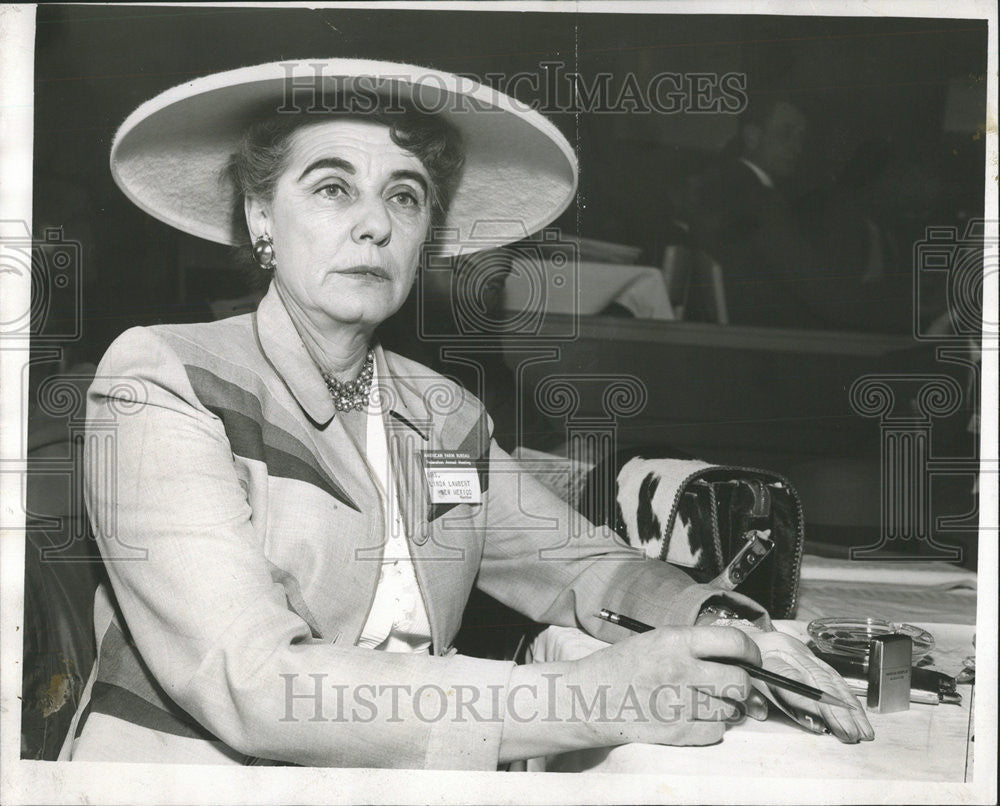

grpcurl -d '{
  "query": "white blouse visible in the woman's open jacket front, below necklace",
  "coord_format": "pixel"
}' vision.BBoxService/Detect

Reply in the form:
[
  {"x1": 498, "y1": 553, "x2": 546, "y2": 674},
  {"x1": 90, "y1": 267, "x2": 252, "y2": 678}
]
[{"x1": 358, "y1": 365, "x2": 431, "y2": 652}]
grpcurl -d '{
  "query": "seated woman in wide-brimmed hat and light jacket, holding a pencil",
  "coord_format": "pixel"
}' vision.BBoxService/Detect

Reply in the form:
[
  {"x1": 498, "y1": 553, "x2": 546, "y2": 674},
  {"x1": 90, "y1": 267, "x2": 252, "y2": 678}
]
[{"x1": 63, "y1": 60, "x2": 870, "y2": 769}]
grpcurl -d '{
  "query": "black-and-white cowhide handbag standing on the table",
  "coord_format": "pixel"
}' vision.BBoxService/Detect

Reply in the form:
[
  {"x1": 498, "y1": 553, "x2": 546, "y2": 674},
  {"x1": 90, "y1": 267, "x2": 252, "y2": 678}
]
[{"x1": 579, "y1": 450, "x2": 804, "y2": 618}]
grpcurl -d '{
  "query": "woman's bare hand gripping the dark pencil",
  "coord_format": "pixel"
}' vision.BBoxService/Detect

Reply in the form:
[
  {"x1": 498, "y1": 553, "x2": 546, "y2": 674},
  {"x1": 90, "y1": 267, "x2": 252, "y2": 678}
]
[{"x1": 501, "y1": 627, "x2": 767, "y2": 760}]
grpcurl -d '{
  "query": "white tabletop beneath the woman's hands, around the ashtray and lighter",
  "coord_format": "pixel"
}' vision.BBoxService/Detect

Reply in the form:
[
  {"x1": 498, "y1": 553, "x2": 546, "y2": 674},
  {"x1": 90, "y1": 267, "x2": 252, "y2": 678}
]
[{"x1": 527, "y1": 621, "x2": 975, "y2": 782}]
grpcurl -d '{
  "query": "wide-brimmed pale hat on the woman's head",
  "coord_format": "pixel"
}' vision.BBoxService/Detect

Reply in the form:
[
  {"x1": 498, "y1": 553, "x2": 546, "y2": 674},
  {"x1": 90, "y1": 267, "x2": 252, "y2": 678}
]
[{"x1": 111, "y1": 59, "x2": 577, "y2": 254}]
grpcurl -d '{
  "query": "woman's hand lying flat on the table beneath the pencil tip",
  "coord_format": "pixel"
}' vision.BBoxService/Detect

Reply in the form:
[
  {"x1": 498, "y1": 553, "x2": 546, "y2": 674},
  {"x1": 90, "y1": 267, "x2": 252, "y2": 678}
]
[{"x1": 748, "y1": 631, "x2": 875, "y2": 744}]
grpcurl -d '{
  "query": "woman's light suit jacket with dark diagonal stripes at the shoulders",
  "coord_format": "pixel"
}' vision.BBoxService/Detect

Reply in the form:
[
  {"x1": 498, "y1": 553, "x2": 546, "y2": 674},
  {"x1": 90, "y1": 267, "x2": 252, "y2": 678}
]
[{"x1": 63, "y1": 291, "x2": 767, "y2": 769}]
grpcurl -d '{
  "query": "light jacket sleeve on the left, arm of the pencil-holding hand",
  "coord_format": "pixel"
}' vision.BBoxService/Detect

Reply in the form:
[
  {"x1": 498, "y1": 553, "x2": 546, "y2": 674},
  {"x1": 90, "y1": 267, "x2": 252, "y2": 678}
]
[{"x1": 86, "y1": 329, "x2": 512, "y2": 770}]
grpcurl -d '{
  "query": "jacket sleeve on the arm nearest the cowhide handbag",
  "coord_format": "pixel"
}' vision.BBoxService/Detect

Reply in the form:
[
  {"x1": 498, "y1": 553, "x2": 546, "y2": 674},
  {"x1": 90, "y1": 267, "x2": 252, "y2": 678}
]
[{"x1": 477, "y1": 442, "x2": 770, "y2": 642}]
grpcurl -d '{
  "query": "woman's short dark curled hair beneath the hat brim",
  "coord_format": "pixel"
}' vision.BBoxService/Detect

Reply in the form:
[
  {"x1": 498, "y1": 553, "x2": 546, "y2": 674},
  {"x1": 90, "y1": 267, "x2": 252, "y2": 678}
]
[{"x1": 223, "y1": 106, "x2": 465, "y2": 287}]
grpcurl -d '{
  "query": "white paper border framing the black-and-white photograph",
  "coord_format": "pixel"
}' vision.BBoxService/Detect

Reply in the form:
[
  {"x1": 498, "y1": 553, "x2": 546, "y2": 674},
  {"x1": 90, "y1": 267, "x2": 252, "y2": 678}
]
[{"x1": 0, "y1": 0, "x2": 1000, "y2": 804}]
